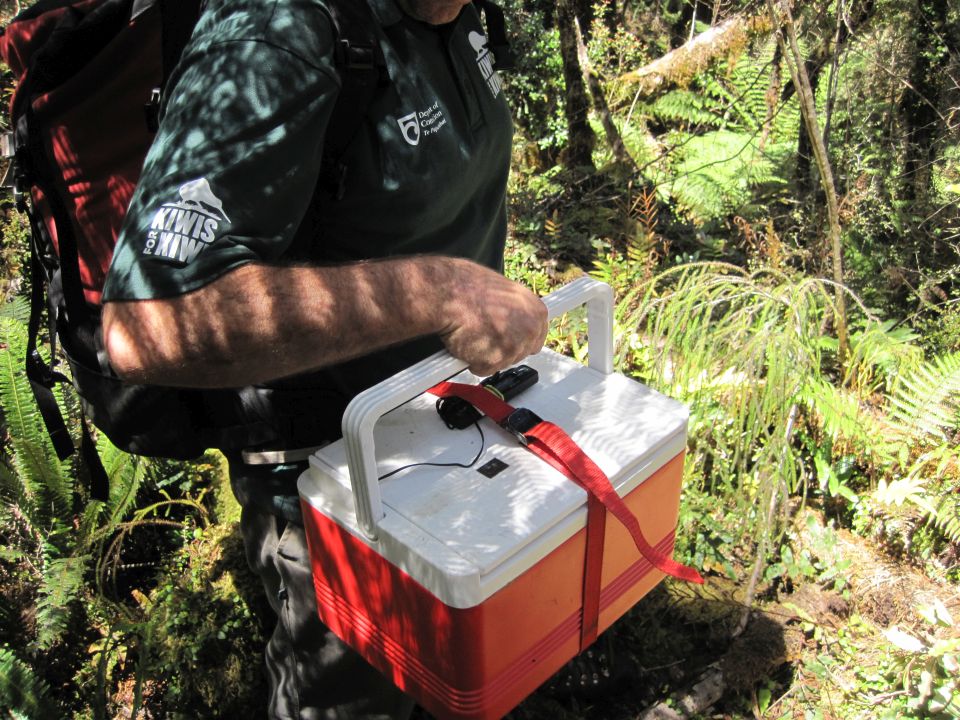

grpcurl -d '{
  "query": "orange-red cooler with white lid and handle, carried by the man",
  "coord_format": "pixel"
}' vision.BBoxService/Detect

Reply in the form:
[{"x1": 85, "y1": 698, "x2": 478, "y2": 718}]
[{"x1": 298, "y1": 278, "x2": 687, "y2": 718}]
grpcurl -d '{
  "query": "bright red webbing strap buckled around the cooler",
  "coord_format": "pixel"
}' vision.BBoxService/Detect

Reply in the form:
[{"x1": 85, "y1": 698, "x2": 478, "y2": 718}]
[{"x1": 429, "y1": 382, "x2": 703, "y2": 650}]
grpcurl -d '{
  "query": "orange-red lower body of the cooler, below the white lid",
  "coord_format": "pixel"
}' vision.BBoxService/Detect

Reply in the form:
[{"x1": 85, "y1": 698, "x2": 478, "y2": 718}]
[{"x1": 304, "y1": 454, "x2": 683, "y2": 720}]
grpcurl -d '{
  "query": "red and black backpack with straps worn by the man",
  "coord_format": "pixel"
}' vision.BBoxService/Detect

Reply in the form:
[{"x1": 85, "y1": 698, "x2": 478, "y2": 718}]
[{"x1": 0, "y1": 0, "x2": 509, "y2": 499}]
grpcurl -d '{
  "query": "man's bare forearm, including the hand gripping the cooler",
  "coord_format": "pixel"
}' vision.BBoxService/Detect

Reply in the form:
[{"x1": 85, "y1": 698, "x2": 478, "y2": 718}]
[{"x1": 103, "y1": 256, "x2": 545, "y2": 387}]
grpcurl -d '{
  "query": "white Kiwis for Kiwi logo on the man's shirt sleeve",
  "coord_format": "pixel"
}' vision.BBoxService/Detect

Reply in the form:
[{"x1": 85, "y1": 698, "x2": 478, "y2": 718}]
[{"x1": 143, "y1": 178, "x2": 230, "y2": 265}]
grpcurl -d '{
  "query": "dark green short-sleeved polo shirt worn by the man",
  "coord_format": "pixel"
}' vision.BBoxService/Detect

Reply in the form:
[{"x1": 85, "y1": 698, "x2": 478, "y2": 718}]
[{"x1": 103, "y1": 0, "x2": 513, "y2": 422}]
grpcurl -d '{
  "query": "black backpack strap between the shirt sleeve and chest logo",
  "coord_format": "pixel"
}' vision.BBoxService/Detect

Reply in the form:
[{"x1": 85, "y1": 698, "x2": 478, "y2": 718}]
[{"x1": 318, "y1": 0, "x2": 390, "y2": 200}]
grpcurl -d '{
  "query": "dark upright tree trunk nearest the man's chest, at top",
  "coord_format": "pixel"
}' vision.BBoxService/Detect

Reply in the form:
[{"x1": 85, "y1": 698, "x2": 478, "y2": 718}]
[{"x1": 557, "y1": 0, "x2": 596, "y2": 171}]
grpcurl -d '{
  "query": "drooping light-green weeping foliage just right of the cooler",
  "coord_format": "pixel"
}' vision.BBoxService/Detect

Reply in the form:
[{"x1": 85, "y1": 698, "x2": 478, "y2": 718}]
[{"x1": 624, "y1": 264, "x2": 829, "y2": 502}]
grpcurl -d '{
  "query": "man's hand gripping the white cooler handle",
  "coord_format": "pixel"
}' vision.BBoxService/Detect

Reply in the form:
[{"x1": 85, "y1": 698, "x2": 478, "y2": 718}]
[{"x1": 440, "y1": 263, "x2": 547, "y2": 377}]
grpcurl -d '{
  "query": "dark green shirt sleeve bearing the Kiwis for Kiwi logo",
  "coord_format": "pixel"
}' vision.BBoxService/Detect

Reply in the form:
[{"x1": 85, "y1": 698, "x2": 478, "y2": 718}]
[{"x1": 103, "y1": 0, "x2": 340, "y2": 301}]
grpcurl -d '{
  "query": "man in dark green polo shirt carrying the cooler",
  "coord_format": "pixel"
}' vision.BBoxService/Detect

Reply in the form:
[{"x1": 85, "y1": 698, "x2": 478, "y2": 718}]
[{"x1": 103, "y1": 0, "x2": 546, "y2": 718}]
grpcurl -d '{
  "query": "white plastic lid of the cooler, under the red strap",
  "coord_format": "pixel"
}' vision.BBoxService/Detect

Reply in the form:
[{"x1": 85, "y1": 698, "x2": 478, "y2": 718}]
[{"x1": 301, "y1": 350, "x2": 688, "y2": 606}]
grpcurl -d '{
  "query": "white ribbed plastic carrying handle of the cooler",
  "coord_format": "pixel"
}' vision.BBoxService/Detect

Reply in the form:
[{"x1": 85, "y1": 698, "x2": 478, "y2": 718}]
[{"x1": 341, "y1": 277, "x2": 613, "y2": 540}]
